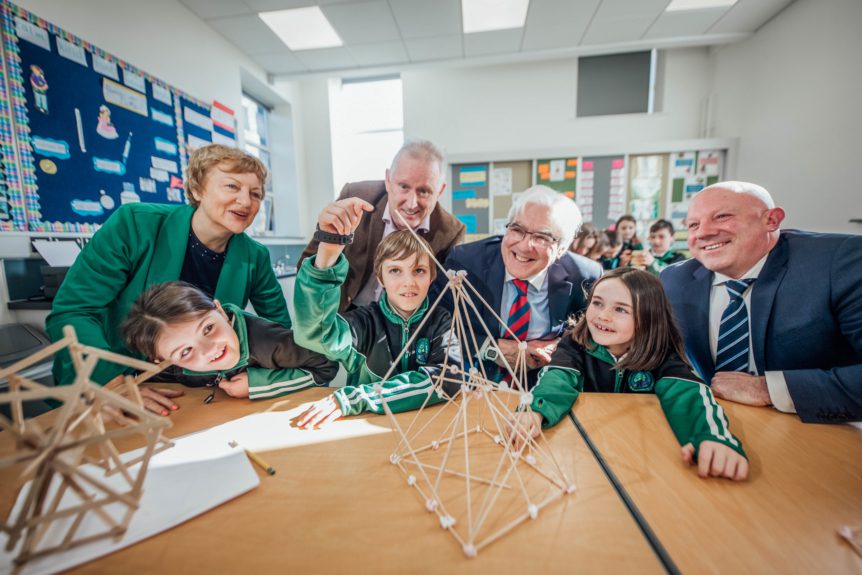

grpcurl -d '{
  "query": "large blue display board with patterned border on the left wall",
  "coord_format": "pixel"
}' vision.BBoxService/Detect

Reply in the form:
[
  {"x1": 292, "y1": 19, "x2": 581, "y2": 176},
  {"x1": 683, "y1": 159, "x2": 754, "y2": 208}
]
[{"x1": 0, "y1": 0, "x2": 236, "y2": 232}]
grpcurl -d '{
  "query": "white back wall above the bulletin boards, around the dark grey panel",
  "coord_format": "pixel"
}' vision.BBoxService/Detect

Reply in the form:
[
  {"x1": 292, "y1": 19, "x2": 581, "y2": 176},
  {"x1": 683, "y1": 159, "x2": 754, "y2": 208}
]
[{"x1": 402, "y1": 48, "x2": 710, "y2": 155}]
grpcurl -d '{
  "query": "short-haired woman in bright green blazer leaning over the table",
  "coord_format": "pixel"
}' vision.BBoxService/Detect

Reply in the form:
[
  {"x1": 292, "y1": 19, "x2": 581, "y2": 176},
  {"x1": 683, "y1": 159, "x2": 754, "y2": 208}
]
[{"x1": 45, "y1": 144, "x2": 291, "y2": 415}]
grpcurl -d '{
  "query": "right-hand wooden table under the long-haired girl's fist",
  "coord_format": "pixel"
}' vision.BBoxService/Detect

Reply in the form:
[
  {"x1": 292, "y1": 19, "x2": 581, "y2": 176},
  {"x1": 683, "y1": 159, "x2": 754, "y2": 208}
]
[{"x1": 573, "y1": 393, "x2": 862, "y2": 573}]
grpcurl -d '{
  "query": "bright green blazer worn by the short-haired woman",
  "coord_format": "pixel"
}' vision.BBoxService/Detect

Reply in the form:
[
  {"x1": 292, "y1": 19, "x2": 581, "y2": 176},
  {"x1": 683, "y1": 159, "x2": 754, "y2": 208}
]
[{"x1": 45, "y1": 203, "x2": 291, "y2": 385}]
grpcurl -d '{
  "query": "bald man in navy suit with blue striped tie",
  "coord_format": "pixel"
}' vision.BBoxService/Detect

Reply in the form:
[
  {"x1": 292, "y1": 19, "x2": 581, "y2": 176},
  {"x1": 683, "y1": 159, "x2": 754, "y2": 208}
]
[{"x1": 661, "y1": 182, "x2": 862, "y2": 423}]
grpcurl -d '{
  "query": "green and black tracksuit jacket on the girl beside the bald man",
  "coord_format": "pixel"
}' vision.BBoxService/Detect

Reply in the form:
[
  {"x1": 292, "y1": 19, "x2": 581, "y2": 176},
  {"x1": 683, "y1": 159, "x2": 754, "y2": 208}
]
[{"x1": 531, "y1": 334, "x2": 745, "y2": 456}]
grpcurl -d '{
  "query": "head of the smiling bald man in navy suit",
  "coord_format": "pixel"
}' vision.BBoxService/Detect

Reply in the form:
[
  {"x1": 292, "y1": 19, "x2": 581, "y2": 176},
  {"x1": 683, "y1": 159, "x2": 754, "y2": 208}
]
[{"x1": 686, "y1": 182, "x2": 784, "y2": 278}]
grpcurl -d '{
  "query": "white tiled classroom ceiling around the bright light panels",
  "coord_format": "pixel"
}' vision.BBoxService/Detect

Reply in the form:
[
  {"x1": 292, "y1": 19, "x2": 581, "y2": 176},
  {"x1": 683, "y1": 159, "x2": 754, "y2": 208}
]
[{"x1": 179, "y1": 0, "x2": 793, "y2": 79}]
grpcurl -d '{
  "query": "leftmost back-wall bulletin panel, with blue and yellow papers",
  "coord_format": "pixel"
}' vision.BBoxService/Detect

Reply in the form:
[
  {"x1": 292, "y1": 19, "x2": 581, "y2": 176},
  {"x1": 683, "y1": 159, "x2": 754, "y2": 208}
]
[{"x1": 452, "y1": 163, "x2": 491, "y2": 242}]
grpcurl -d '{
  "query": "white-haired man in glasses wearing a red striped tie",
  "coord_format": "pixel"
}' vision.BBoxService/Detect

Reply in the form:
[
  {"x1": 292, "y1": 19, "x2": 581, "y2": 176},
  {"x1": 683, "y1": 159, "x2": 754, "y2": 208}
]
[{"x1": 437, "y1": 186, "x2": 598, "y2": 385}]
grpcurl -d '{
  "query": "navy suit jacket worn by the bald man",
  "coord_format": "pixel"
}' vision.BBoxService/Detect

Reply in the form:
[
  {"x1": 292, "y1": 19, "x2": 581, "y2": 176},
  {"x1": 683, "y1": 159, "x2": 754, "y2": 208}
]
[{"x1": 661, "y1": 230, "x2": 862, "y2": 423}]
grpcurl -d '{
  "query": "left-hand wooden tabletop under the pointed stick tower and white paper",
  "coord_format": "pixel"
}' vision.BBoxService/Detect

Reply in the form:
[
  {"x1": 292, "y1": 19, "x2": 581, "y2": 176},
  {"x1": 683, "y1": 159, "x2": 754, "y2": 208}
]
[{"x1": 0, "y1": 386, "x2": 665, "y2": 574}]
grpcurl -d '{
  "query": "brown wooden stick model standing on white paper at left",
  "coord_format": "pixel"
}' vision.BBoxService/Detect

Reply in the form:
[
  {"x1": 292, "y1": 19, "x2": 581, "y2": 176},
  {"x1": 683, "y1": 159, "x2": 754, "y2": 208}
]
[{"x1": 0, "y1": 326, "x2": 172, "y2": 568}]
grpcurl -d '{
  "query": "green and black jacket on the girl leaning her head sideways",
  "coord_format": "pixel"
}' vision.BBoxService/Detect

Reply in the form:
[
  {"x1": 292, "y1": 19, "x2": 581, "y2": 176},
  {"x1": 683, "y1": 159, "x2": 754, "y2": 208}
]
[{"x1": 189, "y1": 304, "x2": 338, "y2": 399}]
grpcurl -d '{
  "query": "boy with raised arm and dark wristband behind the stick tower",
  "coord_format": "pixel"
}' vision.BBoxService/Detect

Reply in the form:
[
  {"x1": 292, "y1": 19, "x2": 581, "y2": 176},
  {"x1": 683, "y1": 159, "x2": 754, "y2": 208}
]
[{"x1": 294, "y1": 198, "x2": 459, "y2": 427}]
